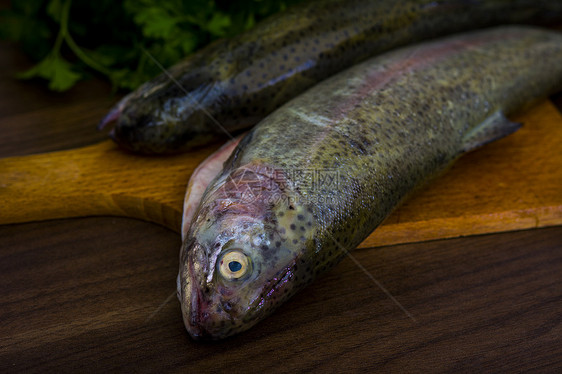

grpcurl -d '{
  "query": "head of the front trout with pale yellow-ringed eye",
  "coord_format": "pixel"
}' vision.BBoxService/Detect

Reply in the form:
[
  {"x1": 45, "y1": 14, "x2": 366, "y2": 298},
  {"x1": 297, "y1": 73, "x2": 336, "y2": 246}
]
[{"x1": 178, "y1": 164, "x2": 314, "y2": 339}]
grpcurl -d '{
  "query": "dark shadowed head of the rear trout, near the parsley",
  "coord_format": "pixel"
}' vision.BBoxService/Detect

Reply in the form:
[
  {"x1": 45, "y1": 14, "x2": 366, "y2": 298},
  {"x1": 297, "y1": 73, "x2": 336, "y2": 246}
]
[{"x1": 98, "y1": 64, "x2": 218, "y2": 154}]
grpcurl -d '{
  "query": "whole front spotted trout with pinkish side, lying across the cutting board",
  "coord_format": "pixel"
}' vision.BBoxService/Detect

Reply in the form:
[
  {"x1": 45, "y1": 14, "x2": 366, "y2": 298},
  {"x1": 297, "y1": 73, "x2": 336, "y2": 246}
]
[{"x1": 178, "y1": 27, "x2": 562, "y2": 339}]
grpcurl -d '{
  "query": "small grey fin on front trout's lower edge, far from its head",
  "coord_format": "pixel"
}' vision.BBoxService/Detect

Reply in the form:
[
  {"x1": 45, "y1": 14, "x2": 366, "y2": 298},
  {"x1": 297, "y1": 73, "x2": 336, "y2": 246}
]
[{"x1": 461, "y1": 110, "x2": 522, "y2": 153}]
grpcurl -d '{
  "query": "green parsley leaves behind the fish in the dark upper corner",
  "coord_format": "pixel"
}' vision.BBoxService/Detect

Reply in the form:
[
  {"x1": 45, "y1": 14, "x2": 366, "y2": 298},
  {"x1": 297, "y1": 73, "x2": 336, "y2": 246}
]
[{"x1": 0, "y1": 0, "x2": 300, "y2": 91}]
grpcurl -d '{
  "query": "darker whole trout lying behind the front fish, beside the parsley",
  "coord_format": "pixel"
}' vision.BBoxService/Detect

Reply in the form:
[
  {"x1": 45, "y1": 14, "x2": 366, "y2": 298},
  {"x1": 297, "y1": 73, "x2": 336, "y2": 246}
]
[{"x1": 100, "y1": 0, "x2": 562, "y2": 154}]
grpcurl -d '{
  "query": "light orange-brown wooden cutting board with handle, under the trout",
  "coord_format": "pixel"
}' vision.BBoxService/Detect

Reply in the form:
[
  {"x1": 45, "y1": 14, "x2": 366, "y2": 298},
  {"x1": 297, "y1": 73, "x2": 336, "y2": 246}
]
[{"x1": 0, "y1": 101, "x2": 562, "y2": 247}]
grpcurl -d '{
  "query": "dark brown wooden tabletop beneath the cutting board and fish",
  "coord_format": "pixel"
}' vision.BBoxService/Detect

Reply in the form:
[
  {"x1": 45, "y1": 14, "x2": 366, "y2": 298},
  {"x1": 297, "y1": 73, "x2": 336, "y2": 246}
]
[{"x1": 0, "y1": 38, "x2": 562, "y2": 373}]
